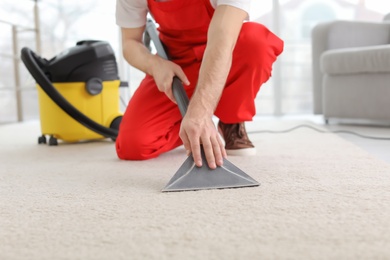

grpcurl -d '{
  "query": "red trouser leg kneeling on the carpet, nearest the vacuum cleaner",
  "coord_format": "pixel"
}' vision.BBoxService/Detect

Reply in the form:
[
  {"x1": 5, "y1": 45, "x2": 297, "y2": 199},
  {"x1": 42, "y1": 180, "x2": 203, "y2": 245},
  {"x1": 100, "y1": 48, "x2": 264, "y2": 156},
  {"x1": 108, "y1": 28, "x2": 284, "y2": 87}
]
[{"x1": 116, "y1": 63, "x2": 200, "y2": 160}]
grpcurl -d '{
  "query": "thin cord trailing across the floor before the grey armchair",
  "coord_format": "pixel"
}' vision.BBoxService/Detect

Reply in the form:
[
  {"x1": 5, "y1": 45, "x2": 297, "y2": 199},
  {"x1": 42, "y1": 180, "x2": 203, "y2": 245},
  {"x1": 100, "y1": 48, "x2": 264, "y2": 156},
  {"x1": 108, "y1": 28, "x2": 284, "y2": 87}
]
[{"x1": 248, "y1": 124, "x2": 390, "y2": 141}]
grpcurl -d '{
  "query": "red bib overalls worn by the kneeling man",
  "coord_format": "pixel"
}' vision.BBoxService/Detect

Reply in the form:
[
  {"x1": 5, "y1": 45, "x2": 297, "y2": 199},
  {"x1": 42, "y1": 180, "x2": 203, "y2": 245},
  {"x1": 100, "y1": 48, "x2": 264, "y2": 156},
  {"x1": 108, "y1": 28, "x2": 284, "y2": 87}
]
[{"x1": 116, "y1": 0, "x2": 283, "y2": 160}]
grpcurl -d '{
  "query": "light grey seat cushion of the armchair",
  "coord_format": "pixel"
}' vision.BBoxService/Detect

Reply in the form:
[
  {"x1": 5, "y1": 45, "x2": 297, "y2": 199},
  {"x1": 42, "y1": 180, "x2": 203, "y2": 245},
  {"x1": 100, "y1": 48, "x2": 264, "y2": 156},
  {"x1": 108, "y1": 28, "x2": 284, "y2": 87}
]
[{"x1": 320, "y1": 44, "x2": 390, "y2": 75}]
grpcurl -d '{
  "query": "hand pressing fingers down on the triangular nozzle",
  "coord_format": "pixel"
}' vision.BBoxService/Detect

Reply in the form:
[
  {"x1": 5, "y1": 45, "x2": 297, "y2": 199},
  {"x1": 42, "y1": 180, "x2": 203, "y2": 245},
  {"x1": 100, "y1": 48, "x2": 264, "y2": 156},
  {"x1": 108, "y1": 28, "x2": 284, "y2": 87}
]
[{"x1": 180, "y1": 111, "x2": 227, "y2": 169}]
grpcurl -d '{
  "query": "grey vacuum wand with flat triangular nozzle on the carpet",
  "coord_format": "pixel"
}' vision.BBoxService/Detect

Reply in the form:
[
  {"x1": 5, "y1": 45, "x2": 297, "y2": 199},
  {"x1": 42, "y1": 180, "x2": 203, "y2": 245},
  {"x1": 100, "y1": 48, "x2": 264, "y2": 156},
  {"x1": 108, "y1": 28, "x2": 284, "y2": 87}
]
[{"x1": 145, "y1": 19, "x2": 260, "y2": 192}]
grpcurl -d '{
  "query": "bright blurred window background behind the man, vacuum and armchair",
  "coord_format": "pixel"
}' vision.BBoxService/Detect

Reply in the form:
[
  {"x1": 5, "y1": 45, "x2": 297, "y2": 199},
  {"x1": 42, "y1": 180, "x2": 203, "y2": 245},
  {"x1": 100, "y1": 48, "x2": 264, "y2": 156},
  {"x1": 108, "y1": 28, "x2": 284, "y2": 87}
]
[{"x1": 0, "y1": 0, "x2": 390, "y2": 124}]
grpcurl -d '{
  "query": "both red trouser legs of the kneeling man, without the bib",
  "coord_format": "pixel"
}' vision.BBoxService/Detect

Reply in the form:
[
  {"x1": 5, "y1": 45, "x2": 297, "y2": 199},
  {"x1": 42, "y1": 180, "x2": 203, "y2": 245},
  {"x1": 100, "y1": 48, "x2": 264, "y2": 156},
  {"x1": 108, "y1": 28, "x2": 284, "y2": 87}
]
[{"x1": 116, "y1": 23, "x2": 283, "y2": 160}]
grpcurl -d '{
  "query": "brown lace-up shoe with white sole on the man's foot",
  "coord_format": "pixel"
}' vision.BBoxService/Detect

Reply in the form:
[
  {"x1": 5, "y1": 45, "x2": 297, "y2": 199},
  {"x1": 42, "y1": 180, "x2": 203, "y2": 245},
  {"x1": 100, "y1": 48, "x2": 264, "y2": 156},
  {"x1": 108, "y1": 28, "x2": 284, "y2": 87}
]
[{"x1": 218, "y1": 121, "x2": 256, "y2": 156}]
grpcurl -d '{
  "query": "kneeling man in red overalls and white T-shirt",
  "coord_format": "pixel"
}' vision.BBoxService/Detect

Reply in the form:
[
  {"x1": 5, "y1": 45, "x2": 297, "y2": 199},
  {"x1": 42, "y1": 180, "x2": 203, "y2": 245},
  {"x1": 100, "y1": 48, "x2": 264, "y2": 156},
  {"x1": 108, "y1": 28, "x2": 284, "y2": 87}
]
[{"x1": 116, "y1": 0, "x2": 283, "y2": 169}]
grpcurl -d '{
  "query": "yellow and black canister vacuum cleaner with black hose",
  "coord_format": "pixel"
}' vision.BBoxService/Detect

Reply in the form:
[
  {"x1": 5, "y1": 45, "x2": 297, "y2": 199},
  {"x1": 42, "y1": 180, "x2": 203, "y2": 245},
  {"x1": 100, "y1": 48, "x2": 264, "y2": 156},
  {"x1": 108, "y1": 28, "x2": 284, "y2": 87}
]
[{"x1": 21, "y1": 40, "x2": 127, "y2": 145}]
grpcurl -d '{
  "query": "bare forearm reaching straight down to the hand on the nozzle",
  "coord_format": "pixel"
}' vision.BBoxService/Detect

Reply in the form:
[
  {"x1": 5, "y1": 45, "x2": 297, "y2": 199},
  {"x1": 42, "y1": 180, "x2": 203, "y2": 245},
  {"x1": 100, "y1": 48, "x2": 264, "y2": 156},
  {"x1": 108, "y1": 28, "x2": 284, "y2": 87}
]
[{"x1": 188, "y1": 6, "x2": 246, "y2": 117}]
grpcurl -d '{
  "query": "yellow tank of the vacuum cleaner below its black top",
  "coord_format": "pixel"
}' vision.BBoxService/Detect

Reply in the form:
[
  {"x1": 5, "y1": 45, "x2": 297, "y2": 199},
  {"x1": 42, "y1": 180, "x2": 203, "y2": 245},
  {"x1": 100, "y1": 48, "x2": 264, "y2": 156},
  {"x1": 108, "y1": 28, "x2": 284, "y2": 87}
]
[{"x1": 37, "y1": 80, "x2": 121, "y2": 142}]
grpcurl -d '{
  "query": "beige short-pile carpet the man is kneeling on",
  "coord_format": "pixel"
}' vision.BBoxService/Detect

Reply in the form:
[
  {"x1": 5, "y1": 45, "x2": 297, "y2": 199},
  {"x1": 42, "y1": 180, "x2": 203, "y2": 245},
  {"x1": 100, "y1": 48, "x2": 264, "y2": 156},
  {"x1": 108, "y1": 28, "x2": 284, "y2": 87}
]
[{"x1": 0, "y1": 122, "x2": 390, "y2": 260}]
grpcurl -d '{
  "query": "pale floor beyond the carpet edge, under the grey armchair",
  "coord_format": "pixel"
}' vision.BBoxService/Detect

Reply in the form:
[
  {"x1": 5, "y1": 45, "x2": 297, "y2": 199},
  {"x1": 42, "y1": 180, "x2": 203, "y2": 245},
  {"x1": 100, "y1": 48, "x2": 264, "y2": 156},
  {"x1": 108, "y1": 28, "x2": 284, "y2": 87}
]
[{"x1": 247, "y1": 115, "x2": 390, "y2": 163}]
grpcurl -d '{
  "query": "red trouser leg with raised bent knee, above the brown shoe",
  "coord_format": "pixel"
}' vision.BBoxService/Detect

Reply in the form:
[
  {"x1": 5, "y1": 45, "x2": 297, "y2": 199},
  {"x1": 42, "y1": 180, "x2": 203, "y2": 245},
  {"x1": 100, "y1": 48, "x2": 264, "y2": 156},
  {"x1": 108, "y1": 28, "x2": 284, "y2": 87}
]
[{"x1": 215, "y1": 22, "x2": 283, "y2": 124}]
